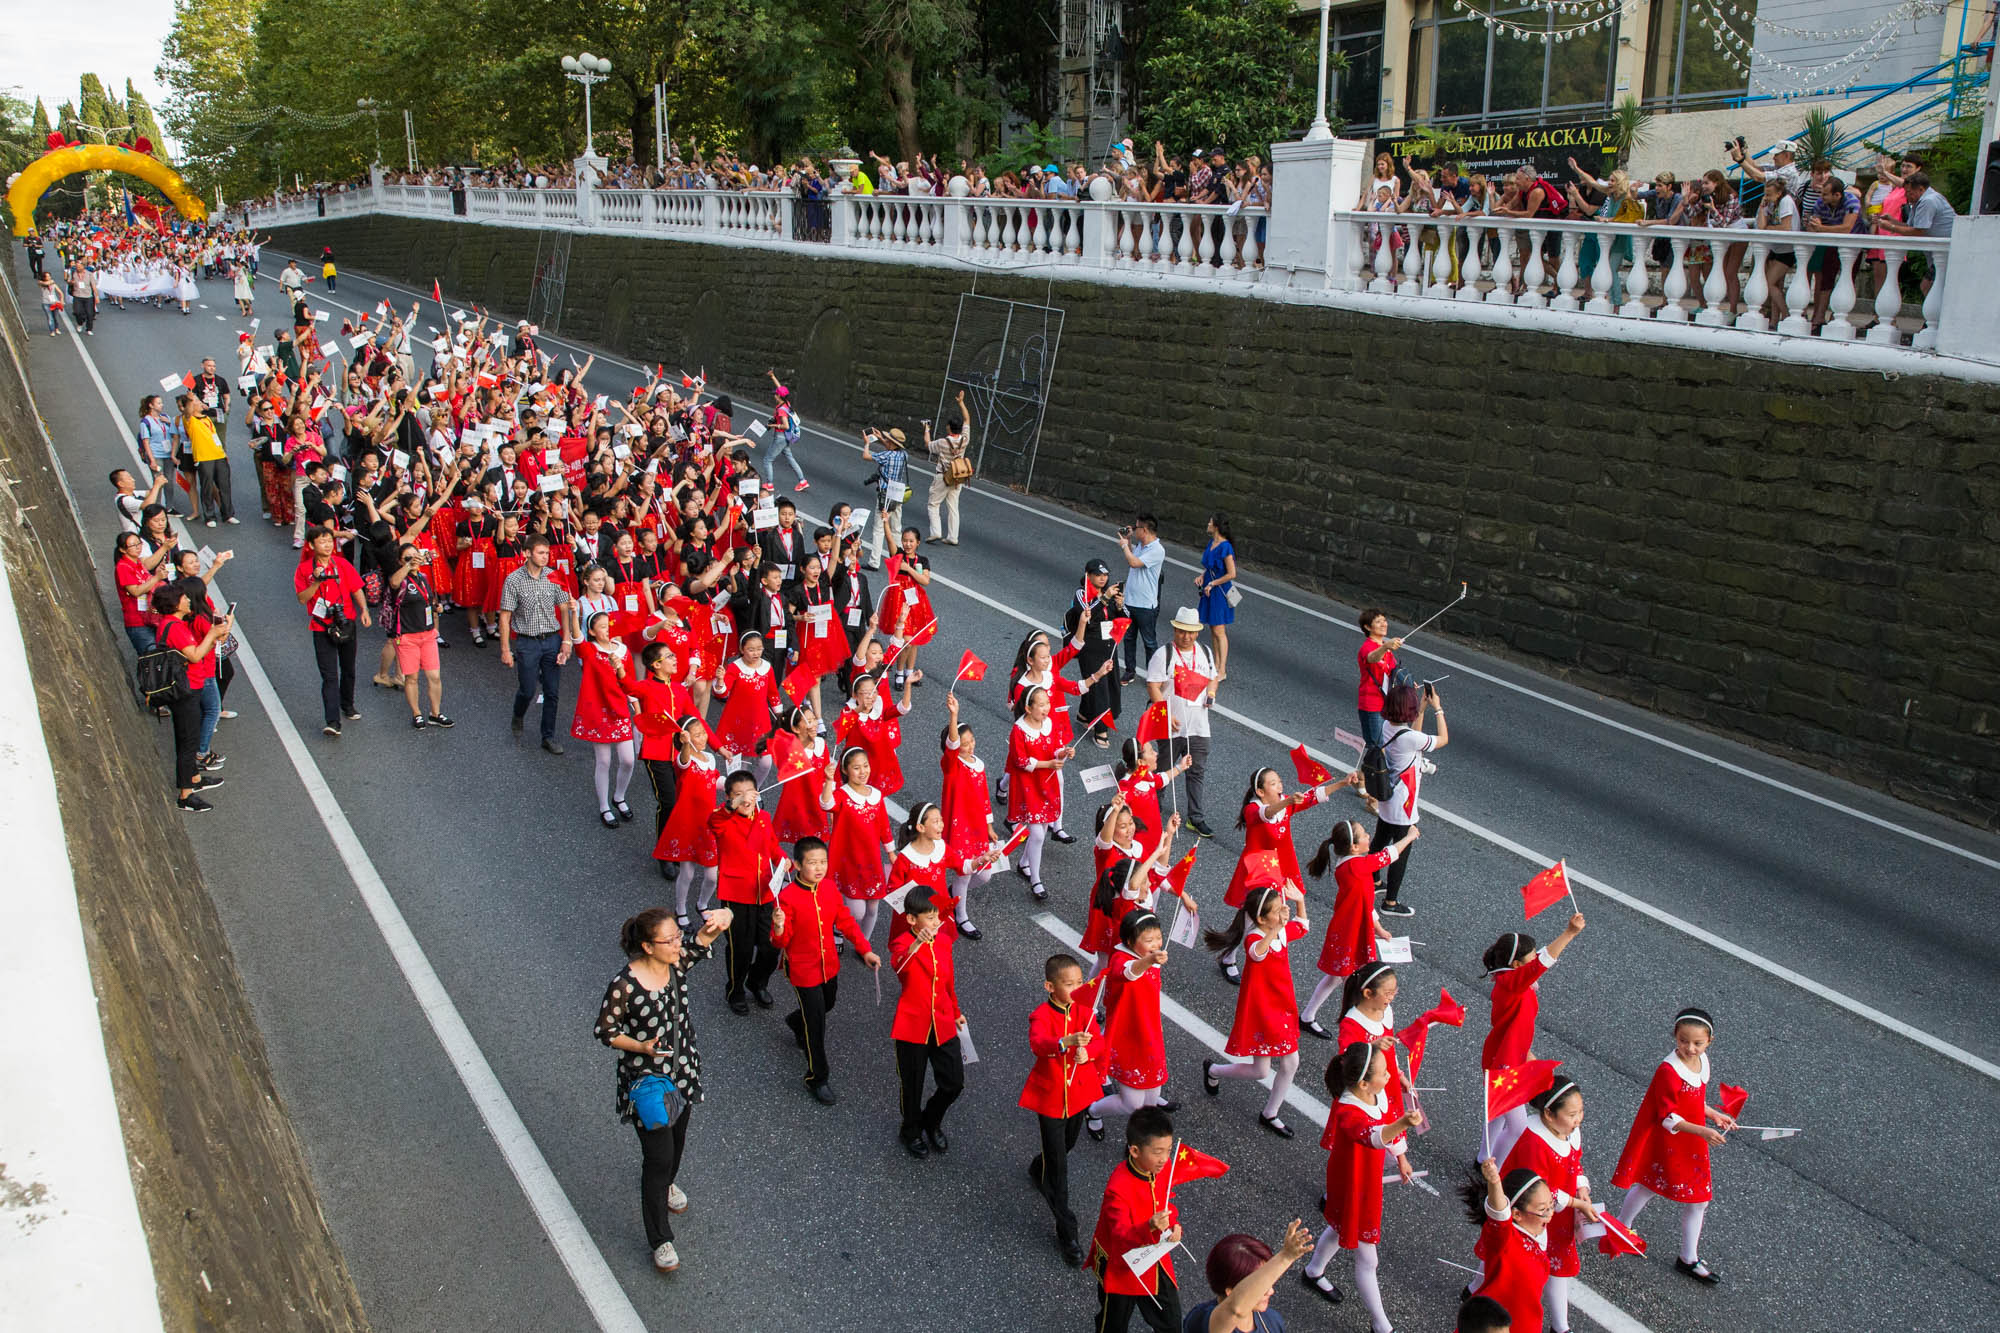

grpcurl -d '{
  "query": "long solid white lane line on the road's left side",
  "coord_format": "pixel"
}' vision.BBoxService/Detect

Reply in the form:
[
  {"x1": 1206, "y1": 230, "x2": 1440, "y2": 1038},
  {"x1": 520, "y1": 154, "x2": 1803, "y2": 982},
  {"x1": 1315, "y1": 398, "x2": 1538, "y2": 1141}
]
[{"x1": 64, "y1": 304, "x2": 646, "y2": 1333}]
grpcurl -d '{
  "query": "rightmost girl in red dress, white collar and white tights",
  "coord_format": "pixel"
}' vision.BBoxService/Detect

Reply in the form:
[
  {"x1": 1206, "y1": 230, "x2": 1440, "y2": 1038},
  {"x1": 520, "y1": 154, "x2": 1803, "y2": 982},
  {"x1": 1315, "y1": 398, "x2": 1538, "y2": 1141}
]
[{"x1": 1612, "y1": 1009, "x2": 1736, "y2": 1285}]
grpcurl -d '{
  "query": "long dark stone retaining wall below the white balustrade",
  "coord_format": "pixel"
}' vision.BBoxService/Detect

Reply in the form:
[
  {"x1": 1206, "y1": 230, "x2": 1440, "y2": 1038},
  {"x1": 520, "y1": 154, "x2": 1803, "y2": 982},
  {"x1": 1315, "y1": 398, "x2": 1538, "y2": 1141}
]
[{"x1": 278, "y1": 216, "x2": 2000, "y2": 827}]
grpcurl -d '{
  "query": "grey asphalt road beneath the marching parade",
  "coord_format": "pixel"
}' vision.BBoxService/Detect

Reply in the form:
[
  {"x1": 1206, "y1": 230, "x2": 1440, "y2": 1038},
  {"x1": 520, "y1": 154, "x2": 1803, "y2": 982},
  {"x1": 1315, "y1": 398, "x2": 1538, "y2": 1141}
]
[{"x1": 16, "y1": 241, "x2": 2000, "y2": 1333}]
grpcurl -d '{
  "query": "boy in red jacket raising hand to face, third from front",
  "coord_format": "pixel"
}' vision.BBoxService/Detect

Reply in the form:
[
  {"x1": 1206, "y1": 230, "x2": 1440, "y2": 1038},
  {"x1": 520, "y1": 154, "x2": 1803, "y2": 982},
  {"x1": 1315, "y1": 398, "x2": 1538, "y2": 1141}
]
[{"x1": 888, "y1": 885, "x2": 966, "y2": 1157}]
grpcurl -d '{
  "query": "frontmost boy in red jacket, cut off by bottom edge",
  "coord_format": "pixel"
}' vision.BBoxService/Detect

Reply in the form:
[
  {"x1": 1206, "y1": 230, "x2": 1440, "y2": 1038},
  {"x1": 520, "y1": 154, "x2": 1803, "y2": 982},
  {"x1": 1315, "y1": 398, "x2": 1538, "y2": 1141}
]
[{"x1": 1090, "y1": 1107, "x2": 1180, "y2": 1333}]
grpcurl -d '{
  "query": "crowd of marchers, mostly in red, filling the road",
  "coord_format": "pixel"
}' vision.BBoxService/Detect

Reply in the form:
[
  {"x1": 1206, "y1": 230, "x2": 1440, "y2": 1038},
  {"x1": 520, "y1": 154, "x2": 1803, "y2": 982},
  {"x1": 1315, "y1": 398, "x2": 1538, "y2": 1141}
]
[{"x1": 86, "y1": 220, "x2": 1768, "y2": 1333}]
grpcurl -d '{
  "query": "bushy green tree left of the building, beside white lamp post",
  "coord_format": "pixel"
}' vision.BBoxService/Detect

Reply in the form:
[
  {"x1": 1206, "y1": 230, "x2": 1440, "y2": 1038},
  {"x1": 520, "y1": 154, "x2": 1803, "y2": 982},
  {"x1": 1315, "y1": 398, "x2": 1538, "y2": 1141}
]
[{"x1": 1138, "y1": 0, "x2": 1316, "y2": 156}]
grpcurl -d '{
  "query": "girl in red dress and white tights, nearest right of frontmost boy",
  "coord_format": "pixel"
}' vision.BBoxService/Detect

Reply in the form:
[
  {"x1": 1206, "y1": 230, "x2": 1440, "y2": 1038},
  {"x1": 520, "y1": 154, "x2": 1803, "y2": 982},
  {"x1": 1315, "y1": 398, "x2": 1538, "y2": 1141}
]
[{"x1": 1304, "y1": 1041, "x2": 1424, "y2": 1333}]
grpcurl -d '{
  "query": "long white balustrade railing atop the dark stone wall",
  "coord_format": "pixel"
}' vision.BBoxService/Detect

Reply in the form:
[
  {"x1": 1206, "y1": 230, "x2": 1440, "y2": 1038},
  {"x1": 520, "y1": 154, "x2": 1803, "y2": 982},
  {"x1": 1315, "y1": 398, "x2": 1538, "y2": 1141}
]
[{"x1": 248, "y1": 184, "x2": 1950, "y2": 360}]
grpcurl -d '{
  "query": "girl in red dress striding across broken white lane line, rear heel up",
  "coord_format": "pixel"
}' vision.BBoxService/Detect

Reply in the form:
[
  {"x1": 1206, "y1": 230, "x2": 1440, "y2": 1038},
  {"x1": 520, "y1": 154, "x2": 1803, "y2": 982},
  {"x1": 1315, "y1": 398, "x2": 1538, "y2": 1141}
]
[{"x1": 1202, "y1": 885, "x2": 1312, "y2": 1139}]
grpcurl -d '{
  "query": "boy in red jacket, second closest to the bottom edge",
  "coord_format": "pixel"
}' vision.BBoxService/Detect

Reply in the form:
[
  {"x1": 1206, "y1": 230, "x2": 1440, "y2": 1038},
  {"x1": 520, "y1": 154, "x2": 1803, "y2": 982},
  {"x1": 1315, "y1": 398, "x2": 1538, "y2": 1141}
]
[{"x1": 1020, "y1": 953, "x2": 1104, "y2": 1269}]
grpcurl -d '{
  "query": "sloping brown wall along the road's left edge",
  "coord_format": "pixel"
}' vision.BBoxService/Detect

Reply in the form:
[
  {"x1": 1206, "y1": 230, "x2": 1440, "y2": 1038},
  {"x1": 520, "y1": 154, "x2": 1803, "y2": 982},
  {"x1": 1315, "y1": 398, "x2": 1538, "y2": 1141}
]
[{"x1": 0, "y1": 246, "x2": 368, "y2": 1333}]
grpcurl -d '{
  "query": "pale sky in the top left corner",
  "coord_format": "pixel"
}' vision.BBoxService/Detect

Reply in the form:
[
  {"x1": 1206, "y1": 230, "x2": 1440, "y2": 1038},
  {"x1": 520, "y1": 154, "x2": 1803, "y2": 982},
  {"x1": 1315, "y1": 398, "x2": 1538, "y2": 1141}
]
[{"x1": 0, "y1": 0, "x2": 174, "y2": 137}]
